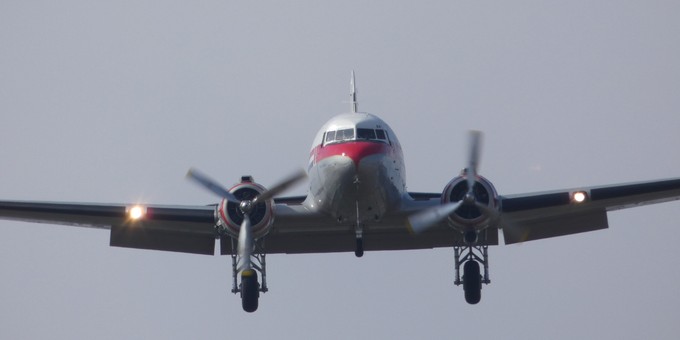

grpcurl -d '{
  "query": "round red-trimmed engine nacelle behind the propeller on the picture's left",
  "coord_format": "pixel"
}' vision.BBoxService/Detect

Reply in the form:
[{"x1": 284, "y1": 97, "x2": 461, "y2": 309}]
[{"x1": 217, "y1": 176, "x2": 274, "y2": 238}]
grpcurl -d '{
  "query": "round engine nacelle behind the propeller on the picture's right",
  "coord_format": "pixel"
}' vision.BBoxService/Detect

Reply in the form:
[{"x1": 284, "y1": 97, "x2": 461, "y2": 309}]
[{"x1": 441, "y1": 173, "x2": 498, "y2": 231}]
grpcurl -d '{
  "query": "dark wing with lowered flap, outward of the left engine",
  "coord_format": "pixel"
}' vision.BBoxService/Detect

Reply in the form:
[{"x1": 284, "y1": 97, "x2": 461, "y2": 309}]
[{"x1": 0, "y1": 201, "x2": 215, "y2": 255}]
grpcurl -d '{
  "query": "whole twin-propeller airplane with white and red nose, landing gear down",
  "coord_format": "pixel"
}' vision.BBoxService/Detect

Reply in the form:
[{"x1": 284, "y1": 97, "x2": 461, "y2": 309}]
[{"x1": 0, "y1": 72, "x2": 680, "y2": 312}]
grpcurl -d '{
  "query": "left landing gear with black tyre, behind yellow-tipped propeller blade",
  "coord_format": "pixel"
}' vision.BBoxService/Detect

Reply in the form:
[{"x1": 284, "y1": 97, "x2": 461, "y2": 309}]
[{"x1": 231, "y1": 238, "x2": 269, "y2": 313}]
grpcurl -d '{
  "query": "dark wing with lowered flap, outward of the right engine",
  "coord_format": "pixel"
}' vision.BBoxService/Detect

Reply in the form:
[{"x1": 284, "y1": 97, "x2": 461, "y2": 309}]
[{"x1": 500, "y1": 178, "x2": 680, "y2": 244}]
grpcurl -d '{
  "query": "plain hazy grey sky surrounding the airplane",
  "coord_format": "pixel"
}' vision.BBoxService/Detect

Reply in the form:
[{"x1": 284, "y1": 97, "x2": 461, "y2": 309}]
[{"x1": 0, "y1": 1, "x2": 680, "y2": 339}]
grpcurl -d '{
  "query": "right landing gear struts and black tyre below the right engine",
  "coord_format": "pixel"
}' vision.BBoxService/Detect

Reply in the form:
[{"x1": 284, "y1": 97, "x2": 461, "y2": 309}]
[{"x1": 453, "y1": 245, "x2": 491, "y2": 305}]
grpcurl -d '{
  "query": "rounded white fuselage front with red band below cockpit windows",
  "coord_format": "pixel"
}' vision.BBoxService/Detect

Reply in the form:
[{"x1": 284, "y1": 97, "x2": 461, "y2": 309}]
[{"x1": 305, "y1": 112, "x2": 406, "y2": 223}]
